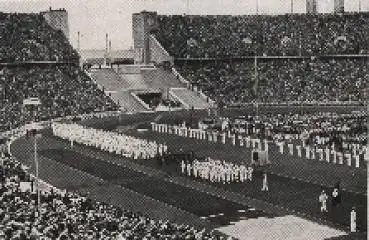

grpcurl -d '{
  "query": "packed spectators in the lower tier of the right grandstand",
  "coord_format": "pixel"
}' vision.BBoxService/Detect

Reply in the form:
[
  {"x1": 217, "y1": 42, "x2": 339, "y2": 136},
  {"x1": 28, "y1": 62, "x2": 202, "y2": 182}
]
[{"x1": 177, "y1": 58, "x2": 369, "y2": 105}]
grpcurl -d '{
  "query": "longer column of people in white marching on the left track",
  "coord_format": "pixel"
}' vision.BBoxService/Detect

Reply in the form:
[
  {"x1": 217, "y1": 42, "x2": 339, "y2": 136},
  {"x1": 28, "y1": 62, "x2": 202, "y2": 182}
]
[{"x1": 52, "y1": 123, "x2": 168, "y2": 159}]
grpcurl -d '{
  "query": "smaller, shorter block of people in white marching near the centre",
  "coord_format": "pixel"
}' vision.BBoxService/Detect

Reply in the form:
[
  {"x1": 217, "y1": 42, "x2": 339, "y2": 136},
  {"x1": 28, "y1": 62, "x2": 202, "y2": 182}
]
[{"x1": 181, "y1": 158, "x2": 254, "y2": 184}]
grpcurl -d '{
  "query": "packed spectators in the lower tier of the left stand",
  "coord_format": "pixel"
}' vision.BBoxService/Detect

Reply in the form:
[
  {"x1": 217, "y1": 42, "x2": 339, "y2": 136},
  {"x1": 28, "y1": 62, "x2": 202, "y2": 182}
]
[{"x1": 0, "y1": 65, "x2": 117, "y2": 130}]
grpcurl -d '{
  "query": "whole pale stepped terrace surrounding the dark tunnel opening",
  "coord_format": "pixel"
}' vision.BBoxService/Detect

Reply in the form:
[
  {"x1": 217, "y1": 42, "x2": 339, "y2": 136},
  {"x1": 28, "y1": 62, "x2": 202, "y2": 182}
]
[{"x1": 90, "y1": 66, "x2": 210, "y2": 112}]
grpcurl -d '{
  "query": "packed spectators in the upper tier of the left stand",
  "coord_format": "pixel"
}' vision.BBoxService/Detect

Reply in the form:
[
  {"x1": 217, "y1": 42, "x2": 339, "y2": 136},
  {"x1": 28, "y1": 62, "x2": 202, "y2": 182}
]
[{"x1": 0, "y1": 12, "x2": 79, "y2": 62}]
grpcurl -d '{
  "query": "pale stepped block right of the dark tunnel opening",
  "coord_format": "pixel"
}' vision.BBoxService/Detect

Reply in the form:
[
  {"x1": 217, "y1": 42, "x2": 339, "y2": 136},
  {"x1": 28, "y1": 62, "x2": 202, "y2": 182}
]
[{"x1": 169, "y1": 88, "x2": 210, "y2": 109}]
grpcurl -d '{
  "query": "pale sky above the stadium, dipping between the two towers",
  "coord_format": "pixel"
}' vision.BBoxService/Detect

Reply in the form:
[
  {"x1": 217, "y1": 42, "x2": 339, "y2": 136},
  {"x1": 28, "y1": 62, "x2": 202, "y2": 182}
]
[{"x1": 0, "y1": 0, "x2": 369, "y2": 49}]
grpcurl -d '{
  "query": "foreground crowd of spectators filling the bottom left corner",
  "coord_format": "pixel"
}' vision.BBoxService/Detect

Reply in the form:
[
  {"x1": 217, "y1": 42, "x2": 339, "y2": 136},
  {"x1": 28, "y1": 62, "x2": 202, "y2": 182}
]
[{"x1": 0, "y1": 153, "x2": 222, "y2": 240}]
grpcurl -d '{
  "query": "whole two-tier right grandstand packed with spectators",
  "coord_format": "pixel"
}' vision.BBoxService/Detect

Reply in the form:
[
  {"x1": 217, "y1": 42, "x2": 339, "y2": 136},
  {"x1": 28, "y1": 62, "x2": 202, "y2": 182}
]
[{"x1": 147, "y1": 13, "x2": 369, "y2": 105}]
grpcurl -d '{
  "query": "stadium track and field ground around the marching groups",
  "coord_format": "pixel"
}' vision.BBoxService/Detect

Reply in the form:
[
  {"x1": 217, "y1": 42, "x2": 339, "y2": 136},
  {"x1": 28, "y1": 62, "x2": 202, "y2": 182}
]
[{"x1": 12, "y1": 109, "x2": 366, "y2": 239}]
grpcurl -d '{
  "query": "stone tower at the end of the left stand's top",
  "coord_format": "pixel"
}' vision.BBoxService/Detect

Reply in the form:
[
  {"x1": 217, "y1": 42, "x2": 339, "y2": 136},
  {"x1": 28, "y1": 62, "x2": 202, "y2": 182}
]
[{"x1": 41, "y1": 7, "x2": 69, "y2": 40}]
